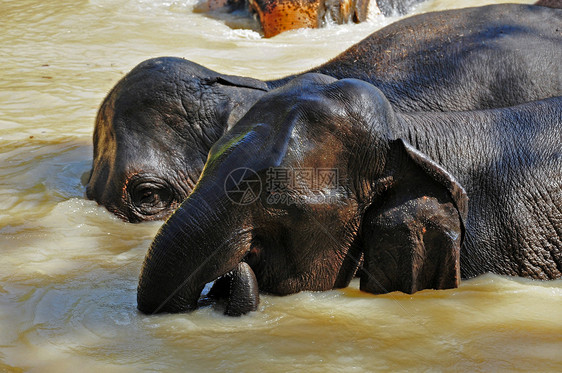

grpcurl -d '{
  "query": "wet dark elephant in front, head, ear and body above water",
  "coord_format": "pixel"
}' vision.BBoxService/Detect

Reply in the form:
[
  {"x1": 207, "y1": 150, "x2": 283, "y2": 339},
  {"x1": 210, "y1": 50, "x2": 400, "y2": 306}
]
[{"x1": 137, "y1": 74, "x2": 562, "y2": 314}]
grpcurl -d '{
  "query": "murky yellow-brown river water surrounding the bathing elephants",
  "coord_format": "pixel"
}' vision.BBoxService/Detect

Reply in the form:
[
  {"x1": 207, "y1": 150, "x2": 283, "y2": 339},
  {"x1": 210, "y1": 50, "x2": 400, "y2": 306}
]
[{"x1": 0, "y1": 0, "x2": 562, "y2": 372}]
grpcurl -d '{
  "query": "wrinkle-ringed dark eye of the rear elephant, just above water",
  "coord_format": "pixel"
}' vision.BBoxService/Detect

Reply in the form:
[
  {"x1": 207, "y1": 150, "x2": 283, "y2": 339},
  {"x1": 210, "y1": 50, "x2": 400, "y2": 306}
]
[{"x1": 129, "y1": 180, "x2": 175, "y2": 215}]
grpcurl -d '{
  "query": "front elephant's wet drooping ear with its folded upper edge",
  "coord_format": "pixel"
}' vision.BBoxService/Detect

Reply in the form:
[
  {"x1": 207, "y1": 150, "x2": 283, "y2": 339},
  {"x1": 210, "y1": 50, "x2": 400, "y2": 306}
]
[{"x1": 361, "y1": 139, "x2": 468, "y2": 294}]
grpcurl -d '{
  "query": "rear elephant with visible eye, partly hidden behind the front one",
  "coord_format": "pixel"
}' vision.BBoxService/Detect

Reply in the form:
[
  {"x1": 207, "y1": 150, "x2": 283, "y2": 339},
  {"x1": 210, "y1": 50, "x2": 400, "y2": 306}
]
[{"x1": 86, "y1": 4, "x2": 562, "y2": 222}]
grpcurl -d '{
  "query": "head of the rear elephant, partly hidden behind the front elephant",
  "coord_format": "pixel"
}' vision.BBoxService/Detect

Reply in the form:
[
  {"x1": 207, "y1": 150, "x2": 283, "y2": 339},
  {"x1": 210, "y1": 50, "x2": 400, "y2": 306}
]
[{"x1": 86, "y1": 57, "x2": 268, "y2": 222}]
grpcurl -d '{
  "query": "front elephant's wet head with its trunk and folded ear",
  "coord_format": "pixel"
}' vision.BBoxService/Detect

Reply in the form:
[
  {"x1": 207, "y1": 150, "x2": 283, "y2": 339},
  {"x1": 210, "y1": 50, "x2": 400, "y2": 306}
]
[{"x1": 137, "y1": 74, "x2": 467, "y2": 313}]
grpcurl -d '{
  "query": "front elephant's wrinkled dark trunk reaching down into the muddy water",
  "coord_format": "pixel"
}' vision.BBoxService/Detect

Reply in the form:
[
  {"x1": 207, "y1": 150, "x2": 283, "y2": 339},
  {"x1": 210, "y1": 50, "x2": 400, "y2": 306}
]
[{"x1": 137, "y1": 183, "x2": 250, "y2": 314}]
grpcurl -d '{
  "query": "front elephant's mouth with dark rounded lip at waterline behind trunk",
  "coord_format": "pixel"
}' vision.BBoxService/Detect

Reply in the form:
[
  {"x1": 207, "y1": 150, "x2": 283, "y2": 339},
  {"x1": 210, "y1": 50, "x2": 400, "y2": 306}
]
[{"x1": 198, "y1": 262, "x2": 259, "y2": 316}]
